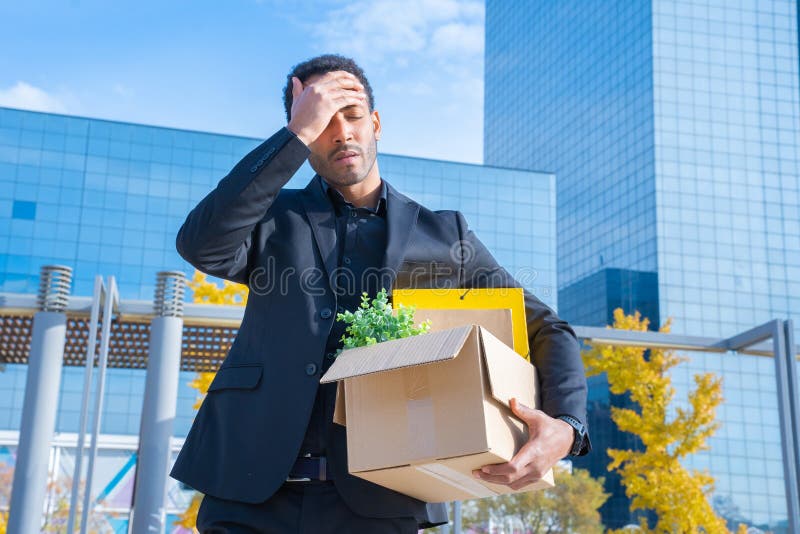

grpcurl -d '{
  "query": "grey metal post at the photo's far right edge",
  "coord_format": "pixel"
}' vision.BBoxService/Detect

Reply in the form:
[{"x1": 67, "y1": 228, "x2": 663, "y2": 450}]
[{"x1": 772, "y1": 321, "x2": 800, "y2": 532}]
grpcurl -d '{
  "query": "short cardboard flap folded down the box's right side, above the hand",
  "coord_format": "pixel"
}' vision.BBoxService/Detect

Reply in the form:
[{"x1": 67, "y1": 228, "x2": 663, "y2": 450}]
[{"x1": 480, "y1": 328, "x2": 538, "y2": 409}]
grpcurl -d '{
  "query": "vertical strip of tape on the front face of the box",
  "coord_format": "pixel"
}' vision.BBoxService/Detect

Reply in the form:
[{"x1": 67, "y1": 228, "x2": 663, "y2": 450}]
[{"x1": 403, "y1": 366, "x2": 436, "y2": 459}]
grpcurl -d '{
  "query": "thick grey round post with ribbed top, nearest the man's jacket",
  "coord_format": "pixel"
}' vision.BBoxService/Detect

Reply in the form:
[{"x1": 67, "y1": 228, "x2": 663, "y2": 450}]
[{"x1": 130, "y1": 271, "x2": 186, "y2": 534}]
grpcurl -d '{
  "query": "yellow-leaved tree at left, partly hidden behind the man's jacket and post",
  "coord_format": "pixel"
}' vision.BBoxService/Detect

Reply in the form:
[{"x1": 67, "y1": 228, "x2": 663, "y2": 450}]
[{"x1": 175, "y1": 271, "x2": 248, "y2": 529}]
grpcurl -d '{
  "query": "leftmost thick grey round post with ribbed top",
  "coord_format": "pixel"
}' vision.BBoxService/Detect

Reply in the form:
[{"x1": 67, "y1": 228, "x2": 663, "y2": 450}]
[{"x1": 8, "y1": 265, "x2": 72, "y2": 534}]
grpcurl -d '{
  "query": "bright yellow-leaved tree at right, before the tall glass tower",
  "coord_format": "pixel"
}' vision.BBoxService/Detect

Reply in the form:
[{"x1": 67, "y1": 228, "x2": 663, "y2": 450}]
[{"x1": 583, "y1": 308, "x2": 728, "y2": 533}]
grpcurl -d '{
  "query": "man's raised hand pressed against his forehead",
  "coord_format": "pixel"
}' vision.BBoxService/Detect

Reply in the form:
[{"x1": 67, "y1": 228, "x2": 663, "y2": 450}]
[{"x1": 287, "y1": 71, "x2": 369, "y2": 145}]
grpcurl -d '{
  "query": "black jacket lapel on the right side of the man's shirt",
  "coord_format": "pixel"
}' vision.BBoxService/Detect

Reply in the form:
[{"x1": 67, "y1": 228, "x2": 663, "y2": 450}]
[{"x1": 382, "y1": 182, "x2": 419, "y2": 291}]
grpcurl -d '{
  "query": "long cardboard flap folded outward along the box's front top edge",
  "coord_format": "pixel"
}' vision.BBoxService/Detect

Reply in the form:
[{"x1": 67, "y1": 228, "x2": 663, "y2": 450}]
[{"x1": 320, "y1": 325, "x2": 474, "y2": 384}]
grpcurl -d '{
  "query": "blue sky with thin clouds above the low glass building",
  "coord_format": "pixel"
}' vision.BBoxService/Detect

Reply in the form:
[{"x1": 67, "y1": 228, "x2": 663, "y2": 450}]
[{"x1": 0, "y1": 0, "x2": 484, "y2": 163}]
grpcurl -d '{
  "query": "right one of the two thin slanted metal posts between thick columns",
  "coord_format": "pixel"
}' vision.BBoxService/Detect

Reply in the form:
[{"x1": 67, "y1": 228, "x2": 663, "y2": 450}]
[{"x1": 81, "y1": 276, "x2": 119, "y2": 534}]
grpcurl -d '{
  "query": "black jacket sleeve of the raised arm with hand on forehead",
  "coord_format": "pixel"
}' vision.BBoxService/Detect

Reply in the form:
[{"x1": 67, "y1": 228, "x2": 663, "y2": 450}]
[{"x1": 175, "y1": 128, "x2": 309, "y2": 284}]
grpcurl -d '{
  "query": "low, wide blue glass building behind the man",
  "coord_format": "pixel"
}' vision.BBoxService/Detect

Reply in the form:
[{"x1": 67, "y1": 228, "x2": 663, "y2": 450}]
[{"x1": 0, "y1": 108, "x2": 556, "y2": 532}]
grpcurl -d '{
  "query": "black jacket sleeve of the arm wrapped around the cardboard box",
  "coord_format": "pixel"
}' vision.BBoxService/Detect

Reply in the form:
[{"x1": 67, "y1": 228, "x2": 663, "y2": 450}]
[{"x1": 456, "y1": 212, "x2": 591, "y2": 455}]
